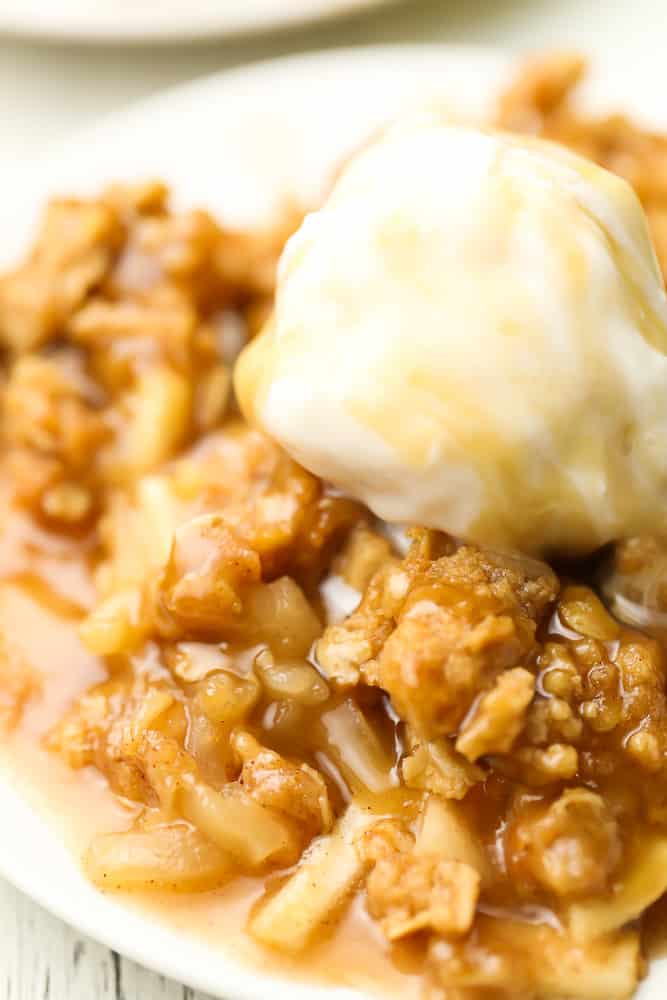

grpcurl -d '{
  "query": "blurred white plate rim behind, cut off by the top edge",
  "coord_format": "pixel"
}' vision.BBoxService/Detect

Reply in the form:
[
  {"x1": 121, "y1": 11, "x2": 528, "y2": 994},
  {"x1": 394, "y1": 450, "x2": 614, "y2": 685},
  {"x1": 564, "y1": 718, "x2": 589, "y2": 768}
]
[{"x1": 0, "y1": 0, "x2": 392, "y2": 42}]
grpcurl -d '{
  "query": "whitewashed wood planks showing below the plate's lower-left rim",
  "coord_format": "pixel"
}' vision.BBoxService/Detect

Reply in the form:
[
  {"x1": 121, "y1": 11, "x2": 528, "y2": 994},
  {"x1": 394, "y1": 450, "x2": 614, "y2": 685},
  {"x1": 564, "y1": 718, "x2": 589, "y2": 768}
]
[{"x1": 0, "y1": 879, "x2": 212, "y2": 1000}]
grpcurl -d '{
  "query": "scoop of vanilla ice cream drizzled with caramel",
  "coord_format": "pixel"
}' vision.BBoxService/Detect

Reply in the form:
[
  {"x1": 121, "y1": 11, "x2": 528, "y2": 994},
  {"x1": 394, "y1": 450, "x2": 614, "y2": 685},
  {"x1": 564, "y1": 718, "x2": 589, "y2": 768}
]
[{"x1": 236, "y1": 120, "x2": 667, "y2": 553}]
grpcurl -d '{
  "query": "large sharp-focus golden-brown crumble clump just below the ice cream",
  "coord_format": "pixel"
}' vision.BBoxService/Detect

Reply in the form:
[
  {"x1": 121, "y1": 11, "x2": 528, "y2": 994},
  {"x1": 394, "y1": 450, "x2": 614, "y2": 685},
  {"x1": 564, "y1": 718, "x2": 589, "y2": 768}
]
[{"x1": 317, "y1": 539, "x2": 556, "y2": 739}]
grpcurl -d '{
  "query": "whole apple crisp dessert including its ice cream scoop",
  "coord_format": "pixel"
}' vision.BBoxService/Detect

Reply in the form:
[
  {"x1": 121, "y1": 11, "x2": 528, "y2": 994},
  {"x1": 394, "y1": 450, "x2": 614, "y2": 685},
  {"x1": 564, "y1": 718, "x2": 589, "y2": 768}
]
[{"x1": 0, "y1": 57, "x2": 667, "y2": 1000}]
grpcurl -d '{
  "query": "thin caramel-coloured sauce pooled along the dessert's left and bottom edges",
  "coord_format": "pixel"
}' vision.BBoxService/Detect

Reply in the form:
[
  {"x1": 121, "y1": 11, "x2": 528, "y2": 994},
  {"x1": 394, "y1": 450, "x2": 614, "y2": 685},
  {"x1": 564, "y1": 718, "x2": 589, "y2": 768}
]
[{"x1": 0, "y1": 521, "x2": 420, "y2": 1000}]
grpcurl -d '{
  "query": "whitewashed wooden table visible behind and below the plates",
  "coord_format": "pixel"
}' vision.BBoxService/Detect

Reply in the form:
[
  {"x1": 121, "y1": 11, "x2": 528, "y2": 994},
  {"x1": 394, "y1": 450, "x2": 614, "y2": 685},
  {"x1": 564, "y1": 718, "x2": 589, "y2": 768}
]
[{"x1": 0, "y1": 0, "x2": 664, "y2": 1000}]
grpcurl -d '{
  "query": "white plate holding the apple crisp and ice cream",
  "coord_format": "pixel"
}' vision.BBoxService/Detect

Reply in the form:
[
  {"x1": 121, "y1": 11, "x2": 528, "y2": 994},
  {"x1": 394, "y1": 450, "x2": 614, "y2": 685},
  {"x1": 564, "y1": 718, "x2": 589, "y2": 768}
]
[{"x1": 0, "y1": 46, "x2": 667, "y2": 1000}]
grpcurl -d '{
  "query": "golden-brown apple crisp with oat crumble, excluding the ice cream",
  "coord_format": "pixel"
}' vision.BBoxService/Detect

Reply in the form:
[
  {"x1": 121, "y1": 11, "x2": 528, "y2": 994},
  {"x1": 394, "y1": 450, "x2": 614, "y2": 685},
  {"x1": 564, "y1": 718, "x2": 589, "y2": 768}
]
[{"x1": 0, "y1": 57, "x2": 667, "y2": 1000}]
